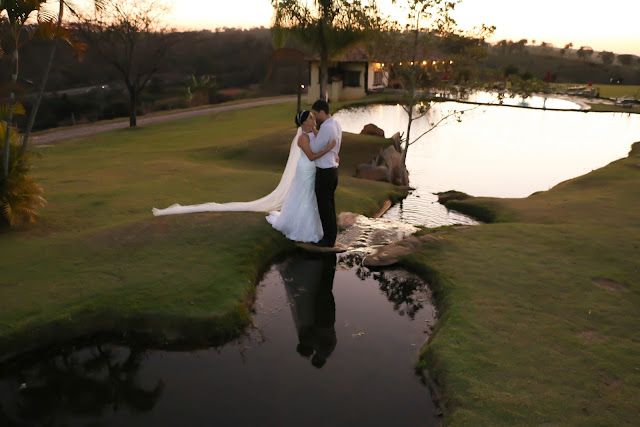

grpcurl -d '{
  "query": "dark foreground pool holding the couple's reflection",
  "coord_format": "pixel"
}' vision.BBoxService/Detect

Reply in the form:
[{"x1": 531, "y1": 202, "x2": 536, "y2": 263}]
[{"x1": 0, "y1": 252, "x2": 439, "y2": 426}]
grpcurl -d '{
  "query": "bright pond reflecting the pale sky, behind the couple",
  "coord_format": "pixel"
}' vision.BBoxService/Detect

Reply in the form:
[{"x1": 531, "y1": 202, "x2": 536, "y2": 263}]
[{"x1": 334, "y1": 102, "x2": 640, "y2": 227}]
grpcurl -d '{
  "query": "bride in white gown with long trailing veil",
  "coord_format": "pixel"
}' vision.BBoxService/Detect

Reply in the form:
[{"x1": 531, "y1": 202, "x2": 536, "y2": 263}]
[{"x1": 152, "y1": 110, "x2": 336, "y2": 242}]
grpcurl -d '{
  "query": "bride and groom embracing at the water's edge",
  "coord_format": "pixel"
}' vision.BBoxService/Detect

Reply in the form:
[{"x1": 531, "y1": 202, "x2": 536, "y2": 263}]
[{"x1": 153, "y1": 100, "x2": 342, "y2": 247}]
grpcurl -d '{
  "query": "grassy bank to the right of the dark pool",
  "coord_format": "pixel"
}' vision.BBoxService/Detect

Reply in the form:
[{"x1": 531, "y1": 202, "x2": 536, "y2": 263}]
[{"x1": 405, "y1": 143, "x2": 640, "y2": 426}]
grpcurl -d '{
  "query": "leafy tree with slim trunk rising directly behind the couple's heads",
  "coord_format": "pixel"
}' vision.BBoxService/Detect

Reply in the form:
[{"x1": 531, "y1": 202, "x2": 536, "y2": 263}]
[{"x1": 271, "y1": 0, "x2": 383, "y2": 100}]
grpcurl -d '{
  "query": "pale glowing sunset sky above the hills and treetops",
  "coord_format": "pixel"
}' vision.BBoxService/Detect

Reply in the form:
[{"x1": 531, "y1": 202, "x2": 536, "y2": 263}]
[{"x1": 171, "y1": 0, "x2": 640, "y2": 55}]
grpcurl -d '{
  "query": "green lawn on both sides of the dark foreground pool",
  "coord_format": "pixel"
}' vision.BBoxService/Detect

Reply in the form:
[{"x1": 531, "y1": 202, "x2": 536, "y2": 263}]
[{"x1": 0, "y1": 93, "x2": 640, "y2": 426}]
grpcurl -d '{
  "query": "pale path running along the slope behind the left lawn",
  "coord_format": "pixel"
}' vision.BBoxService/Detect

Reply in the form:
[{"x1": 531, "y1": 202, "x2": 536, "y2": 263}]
[{"x1": 29, "y1": 96, "x2": 297, "y2": 145}]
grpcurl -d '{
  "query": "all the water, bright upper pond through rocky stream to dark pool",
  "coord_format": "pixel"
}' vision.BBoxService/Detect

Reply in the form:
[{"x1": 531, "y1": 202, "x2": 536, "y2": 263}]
[{"x1": 0, "y1": 102, "x2": 640, "y2": 426}]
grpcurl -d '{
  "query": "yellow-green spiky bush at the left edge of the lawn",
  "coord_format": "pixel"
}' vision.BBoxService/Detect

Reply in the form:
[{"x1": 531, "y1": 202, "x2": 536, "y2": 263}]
[{"x1": 0, "y1": 124, "x2": 46, "y2": 227}]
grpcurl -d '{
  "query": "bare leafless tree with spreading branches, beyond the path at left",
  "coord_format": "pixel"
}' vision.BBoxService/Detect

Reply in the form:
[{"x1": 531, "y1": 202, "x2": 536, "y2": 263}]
[{"x1": 79, "y1": 0, "x2": 171, "y2": 127}]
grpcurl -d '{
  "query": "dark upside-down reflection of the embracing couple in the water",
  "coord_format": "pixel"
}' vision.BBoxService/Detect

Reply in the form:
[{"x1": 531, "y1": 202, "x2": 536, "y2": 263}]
[{"x1": 280, "y1": 254, "x2": 337, "y2": 368}]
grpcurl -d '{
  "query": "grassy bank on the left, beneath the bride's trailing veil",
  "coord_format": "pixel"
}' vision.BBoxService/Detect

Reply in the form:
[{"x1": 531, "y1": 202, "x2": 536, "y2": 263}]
[{"x1": 0, "y1": 104, "x2": 400, "y2": 356}]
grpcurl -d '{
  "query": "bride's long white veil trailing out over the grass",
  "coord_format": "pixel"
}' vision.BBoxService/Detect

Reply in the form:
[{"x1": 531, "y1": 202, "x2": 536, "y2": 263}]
[{"x1": 152, "y1": 128, "x2": 302, "y2": 216}]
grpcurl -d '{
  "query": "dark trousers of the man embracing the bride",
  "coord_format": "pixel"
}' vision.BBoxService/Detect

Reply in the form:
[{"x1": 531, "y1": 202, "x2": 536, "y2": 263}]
[{"x1": 316, "y1": 168, "x2": 338, "y2": 246}]
